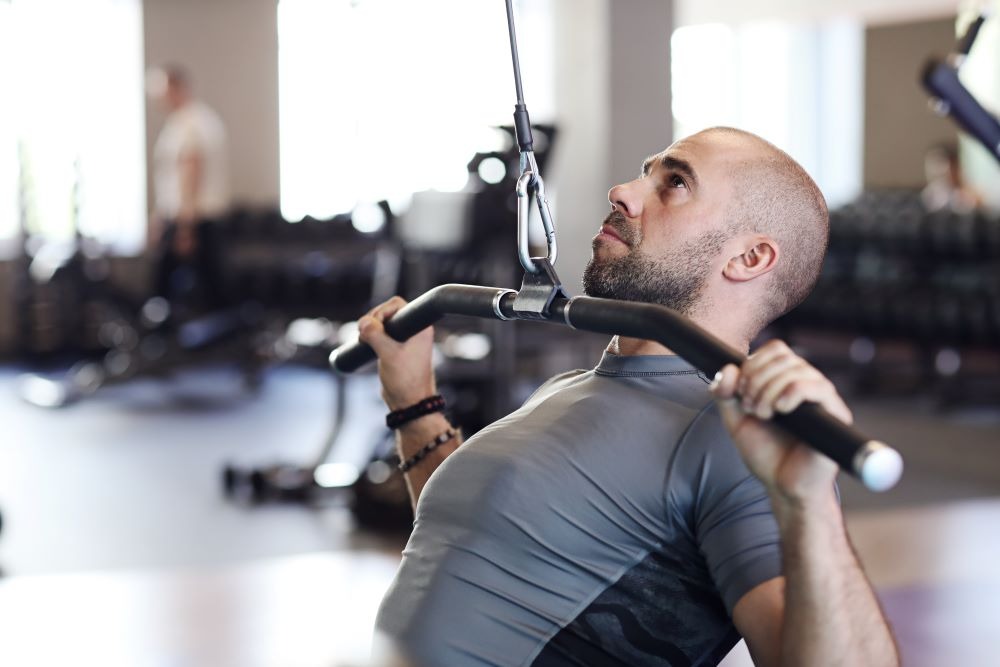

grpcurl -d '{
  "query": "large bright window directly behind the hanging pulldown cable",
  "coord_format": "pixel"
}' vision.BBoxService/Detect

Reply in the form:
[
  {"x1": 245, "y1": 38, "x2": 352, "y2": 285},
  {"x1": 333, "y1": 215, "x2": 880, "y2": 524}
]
[{"x1": 278, "y1": 0, "x2": 554, "y2": 220}]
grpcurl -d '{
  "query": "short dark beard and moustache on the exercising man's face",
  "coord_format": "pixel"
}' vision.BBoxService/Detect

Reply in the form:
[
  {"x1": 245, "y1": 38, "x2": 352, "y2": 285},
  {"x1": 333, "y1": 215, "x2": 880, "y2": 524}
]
[{"x1": 583, "y1": 213, "x2": 726, "y2": 316}]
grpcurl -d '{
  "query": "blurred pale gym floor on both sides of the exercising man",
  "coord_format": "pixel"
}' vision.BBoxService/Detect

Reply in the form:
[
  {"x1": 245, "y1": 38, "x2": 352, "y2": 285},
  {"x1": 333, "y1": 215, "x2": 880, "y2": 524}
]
[{"x1": 0, "y1": 368, "x2": 1000, "y2": 667}]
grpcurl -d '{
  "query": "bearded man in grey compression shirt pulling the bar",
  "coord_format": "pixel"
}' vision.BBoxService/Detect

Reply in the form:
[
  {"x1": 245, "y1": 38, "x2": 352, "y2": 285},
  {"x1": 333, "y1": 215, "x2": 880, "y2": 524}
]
[{"x1": 359, "y1": 128, "x2": 898, "y2": 667}]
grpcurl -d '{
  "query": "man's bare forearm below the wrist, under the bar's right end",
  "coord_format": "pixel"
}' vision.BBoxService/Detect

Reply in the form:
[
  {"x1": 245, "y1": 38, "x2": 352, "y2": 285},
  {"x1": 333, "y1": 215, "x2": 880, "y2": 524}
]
[{"x1": 772, "y1": 492, "x2": 899, "y2": 667}]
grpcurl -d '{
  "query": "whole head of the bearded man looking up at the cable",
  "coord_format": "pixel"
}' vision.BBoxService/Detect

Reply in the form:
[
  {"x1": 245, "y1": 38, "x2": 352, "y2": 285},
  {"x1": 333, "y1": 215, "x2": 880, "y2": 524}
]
[{"x1": 583, "y1": 127, "x2": 829, "y2": 343}]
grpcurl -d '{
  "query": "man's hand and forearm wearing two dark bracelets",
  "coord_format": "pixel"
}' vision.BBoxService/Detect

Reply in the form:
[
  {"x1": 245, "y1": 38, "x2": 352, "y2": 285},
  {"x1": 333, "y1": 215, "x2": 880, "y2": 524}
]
[{"x1": 358, "y1": 296, "x2": 462, "y2": 509}]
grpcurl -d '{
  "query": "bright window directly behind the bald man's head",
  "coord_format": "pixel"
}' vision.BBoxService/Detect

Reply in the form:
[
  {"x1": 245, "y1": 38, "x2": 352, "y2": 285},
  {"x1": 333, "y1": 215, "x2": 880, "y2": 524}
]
[{"x1": 671, "y1": 21, "x2": 864, "y2": 206}]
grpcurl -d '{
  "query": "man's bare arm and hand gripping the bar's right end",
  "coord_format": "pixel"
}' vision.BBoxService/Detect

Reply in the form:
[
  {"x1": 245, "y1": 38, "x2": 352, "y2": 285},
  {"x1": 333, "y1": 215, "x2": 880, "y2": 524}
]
[{"x1": 713, "y1": 341, "x2": 899, "y2": 666}]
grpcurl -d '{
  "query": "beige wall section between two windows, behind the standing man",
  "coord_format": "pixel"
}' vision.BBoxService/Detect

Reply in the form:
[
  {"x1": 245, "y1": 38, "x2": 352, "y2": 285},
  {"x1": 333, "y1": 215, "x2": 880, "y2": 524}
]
[{"x1": 143, "y1": 0, "x2": 279, "y2": 211}]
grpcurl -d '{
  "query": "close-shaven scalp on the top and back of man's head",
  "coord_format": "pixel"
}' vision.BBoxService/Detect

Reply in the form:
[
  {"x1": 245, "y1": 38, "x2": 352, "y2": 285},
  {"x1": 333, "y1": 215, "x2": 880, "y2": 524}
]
[{"x1": 694, "y1": 127, "x2": 830, "y2": 333}]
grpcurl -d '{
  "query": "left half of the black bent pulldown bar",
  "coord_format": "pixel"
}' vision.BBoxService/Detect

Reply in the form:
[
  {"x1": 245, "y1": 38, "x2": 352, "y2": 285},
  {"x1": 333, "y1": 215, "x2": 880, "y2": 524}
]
[{"x1": 330, "y1": 285, "x2": 517, "y2": 373}]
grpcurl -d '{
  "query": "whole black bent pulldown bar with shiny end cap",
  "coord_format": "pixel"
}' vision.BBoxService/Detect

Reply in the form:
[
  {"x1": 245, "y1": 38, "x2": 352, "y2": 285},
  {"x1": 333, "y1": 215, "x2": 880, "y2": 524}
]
[{"x1": 330, "y1": 285, "x2": 903, "y2": 491}]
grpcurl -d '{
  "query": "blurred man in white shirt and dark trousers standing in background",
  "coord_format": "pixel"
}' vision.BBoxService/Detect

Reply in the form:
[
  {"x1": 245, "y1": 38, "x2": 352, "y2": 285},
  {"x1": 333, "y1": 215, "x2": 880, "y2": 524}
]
[{"x1": 151, "y1": 66, "x2": 230, "y2": 307}]
